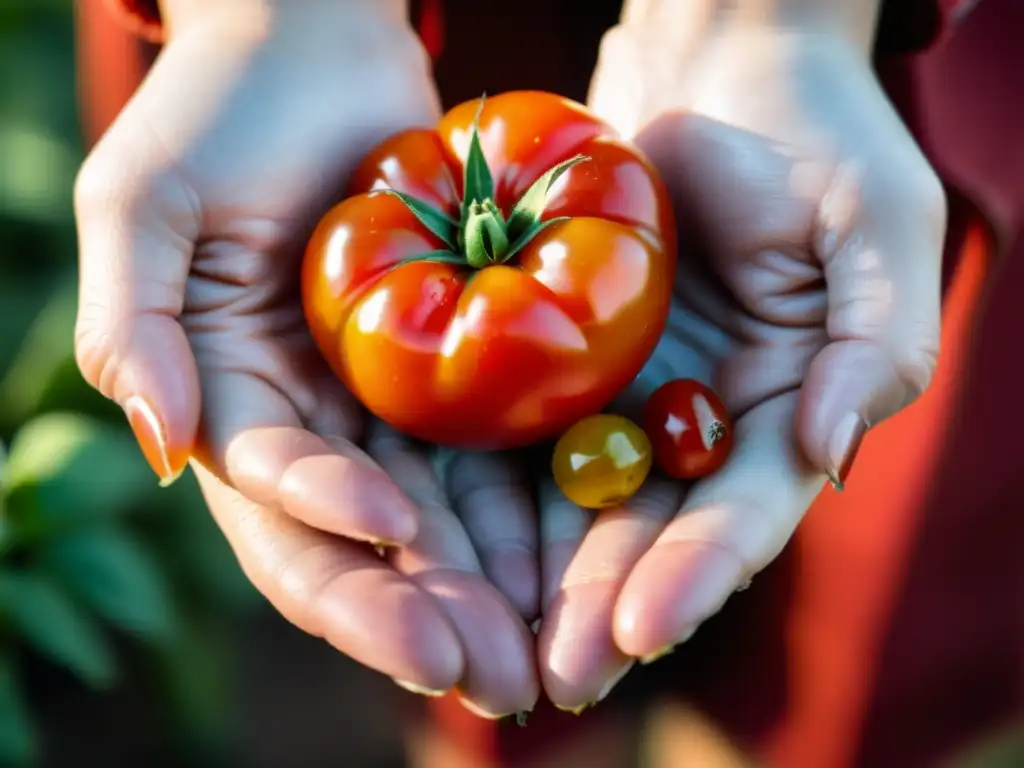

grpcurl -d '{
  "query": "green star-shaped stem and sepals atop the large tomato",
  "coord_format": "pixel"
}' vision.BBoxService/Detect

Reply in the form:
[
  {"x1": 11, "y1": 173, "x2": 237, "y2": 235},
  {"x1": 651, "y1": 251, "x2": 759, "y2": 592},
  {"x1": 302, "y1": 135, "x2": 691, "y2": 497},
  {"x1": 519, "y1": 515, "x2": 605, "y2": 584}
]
[{"x1": 384, "y1": 96, "x2": 590, "y2": 269}]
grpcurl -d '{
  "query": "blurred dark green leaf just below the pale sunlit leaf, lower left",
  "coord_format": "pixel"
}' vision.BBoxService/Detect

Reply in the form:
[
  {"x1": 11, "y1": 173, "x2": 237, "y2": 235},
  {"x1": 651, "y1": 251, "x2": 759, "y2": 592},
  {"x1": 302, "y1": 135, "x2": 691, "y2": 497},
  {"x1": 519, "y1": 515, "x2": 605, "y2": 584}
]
[{"x1": 40, "y1": 525, "x2": 175, "y2": 644}]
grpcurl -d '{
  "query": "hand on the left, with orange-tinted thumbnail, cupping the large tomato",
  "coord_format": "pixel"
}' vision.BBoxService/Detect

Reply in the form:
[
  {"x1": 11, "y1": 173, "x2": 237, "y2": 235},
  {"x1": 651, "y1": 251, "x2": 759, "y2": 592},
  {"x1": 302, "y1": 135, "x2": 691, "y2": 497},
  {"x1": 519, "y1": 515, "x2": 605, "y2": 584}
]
[{"x1": 76, "y1": 0, "x2": 538, "y2": 714}]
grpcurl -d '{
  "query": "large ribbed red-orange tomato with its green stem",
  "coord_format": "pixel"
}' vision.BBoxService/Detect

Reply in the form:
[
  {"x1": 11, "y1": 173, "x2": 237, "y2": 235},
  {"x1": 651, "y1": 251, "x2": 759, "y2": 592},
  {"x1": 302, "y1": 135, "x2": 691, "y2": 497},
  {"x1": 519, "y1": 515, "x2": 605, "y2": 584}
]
[{"x1": 302, "y1": 91, "x2": 676, "y2": 449}]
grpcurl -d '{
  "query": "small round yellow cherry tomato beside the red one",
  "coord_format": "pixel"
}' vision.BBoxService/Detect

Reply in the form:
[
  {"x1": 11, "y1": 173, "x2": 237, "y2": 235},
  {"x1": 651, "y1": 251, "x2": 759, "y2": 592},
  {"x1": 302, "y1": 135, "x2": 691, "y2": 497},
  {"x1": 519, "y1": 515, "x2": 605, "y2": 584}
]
[{"x1": 551, "y1": 414, "x2": 652, "y2": 509}]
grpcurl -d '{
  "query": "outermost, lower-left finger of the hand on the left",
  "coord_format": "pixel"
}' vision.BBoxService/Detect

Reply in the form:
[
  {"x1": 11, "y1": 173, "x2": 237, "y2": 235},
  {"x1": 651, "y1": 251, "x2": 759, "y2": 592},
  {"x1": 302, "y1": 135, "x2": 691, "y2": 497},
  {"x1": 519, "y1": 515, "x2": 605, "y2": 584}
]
[{"x1": 196, "y1": 465, "x2": 463, "y2": 694}]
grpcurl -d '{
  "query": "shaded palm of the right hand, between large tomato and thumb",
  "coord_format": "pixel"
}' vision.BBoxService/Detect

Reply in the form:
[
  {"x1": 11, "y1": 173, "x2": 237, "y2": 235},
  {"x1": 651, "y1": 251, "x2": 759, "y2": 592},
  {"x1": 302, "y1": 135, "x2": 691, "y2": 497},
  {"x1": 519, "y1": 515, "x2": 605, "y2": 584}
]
[{"x1": 622, "y1": 105, "x2": 831, "y2": 468}]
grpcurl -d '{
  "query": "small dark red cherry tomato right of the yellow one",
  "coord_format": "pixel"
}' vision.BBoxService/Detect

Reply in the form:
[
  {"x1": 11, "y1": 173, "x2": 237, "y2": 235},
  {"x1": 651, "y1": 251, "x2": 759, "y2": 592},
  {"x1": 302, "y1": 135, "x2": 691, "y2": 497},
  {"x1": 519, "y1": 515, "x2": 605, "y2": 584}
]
[{"x1": 643, "y1": 379, "x2": 733, "y2": 479}]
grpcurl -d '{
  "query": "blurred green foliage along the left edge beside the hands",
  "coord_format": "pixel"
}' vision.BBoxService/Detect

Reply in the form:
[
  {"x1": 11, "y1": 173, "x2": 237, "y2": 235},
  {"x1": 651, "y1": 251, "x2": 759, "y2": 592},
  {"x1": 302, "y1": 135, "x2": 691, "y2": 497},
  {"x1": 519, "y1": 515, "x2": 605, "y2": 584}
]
[{"x1": 0, "y1": 0, "x2": 260, "y2": 765}]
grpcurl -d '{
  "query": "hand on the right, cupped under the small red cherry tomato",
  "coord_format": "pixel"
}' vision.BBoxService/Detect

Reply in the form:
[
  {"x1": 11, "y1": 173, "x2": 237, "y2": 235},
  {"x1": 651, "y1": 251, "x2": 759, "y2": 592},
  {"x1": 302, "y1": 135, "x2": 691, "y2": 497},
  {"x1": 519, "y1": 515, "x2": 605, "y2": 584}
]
[{"x1": 539, "y1": 4, "x2": 945, "y2": 709}]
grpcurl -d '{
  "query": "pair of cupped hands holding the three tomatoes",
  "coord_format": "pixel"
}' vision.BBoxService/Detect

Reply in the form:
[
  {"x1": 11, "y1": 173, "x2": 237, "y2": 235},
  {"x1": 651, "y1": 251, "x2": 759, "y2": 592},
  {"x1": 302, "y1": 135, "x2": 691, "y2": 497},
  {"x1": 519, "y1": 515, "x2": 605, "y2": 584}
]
[{"x1": 76, "y1": 4, "x2": 945, "y2": 718}]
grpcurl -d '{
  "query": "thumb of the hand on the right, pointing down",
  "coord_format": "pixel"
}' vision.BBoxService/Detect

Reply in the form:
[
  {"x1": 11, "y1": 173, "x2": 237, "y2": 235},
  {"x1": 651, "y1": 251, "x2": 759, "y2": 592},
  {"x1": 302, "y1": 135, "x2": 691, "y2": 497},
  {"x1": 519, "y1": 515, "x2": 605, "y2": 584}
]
[{"x1": 797, "y1": 162, "x2": 946, "y2": 489}]
